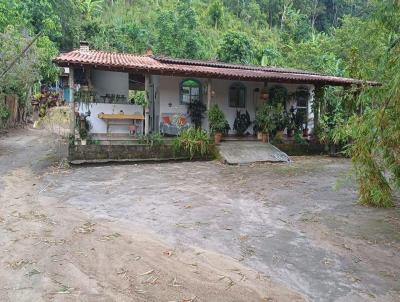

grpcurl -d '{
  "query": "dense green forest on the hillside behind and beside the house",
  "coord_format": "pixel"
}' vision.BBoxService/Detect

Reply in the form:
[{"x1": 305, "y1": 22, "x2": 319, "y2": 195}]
[{"x1": 0, "y1": 0, "x2": 400, "y2": 206}]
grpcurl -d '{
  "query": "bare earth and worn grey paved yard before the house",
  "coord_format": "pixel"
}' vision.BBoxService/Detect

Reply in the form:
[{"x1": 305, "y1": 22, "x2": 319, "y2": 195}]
[{"x1": 0, "y1": 129, "x2": 400, "y2": 301}]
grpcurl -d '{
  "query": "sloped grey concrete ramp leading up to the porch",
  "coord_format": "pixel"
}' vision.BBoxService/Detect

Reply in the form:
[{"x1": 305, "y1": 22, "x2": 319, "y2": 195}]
[{"x1": 218, "y1": 140, "x2": 290, "y2": 165}]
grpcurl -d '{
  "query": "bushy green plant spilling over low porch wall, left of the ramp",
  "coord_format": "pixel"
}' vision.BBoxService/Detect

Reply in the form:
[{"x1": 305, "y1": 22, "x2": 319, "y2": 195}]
[{"x1": 172, "y1": 127, "x2": 210, "y2": 159}]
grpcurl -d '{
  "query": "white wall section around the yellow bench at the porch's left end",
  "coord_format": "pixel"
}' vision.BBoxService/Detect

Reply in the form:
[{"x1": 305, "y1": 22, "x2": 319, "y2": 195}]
[{"x1": 79, "y1": 70, "x2": 143, "y2": 133}]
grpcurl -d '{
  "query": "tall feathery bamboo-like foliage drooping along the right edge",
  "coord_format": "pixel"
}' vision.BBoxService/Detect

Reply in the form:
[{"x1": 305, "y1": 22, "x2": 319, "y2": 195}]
[{"x1": 333, "y1": 4, "x2": 400, "y2": 207}]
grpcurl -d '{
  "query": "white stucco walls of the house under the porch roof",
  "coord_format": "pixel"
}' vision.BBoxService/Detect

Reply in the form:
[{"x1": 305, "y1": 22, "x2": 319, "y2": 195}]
[{"x1": 79, "y1": 70, "x2": 314, "y2": 133}]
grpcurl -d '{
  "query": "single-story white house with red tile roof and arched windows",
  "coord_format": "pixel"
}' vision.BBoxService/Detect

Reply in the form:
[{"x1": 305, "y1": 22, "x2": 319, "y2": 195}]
[{"x1": 54, "y1": 43, "x2": 372, "y2": 138}]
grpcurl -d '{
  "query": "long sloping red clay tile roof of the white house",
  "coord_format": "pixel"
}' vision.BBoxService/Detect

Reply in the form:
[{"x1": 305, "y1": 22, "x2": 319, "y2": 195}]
[{"x1": 54, "y1": 50, "x2": 377, "y2": 86}]
